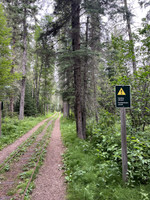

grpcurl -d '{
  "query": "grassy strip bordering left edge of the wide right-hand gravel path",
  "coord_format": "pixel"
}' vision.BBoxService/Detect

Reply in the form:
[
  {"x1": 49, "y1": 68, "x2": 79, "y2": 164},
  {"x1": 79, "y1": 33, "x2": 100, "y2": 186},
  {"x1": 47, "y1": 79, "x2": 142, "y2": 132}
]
[{"x1": 6, "y1": 116, "x2": 58, "y2": 200}]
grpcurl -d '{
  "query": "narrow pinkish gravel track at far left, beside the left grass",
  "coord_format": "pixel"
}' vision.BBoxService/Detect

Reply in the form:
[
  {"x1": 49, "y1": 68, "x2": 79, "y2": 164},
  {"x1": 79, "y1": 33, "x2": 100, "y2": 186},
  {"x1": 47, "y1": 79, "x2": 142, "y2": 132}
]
[{"x1": 0, "y1": 119, "x2": 48, "y2": 163}]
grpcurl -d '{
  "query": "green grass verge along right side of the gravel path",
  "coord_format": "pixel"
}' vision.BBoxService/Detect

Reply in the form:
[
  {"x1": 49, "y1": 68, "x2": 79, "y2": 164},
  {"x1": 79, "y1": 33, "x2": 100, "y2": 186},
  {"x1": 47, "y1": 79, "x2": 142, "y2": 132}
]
[{"x1": 61, "y1": 118, "x2": 150, "y2": 200}]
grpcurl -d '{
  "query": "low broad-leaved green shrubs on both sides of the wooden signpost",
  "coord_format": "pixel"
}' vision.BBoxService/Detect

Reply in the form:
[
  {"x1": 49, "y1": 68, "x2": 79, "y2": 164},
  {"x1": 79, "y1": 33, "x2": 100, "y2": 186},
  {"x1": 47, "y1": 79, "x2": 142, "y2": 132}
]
[{"x1": 91, "y1": 111, "x2": 150, "y2": 184}]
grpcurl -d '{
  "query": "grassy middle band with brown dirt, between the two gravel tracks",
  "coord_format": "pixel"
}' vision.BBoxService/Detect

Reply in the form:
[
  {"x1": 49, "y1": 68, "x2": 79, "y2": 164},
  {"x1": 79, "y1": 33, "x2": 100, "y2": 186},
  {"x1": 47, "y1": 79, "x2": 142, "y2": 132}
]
[{"x1": 0, "y1": 114, "x2": 58, "y2": 200}]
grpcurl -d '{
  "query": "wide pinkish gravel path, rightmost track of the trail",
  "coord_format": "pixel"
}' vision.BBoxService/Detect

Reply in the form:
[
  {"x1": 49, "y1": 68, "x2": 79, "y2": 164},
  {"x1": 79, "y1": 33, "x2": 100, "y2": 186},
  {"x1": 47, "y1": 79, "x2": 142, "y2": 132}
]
[{"x1": 31, "y1": 118, "x2": 66, "y2": 200}]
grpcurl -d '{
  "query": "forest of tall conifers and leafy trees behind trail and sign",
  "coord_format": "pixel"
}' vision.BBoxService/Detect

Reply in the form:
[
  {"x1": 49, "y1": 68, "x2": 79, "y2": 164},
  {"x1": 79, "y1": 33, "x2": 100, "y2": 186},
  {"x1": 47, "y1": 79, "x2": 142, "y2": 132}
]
[{"x1": 0, "y1": 0, "x2": 150, "y2": 139}]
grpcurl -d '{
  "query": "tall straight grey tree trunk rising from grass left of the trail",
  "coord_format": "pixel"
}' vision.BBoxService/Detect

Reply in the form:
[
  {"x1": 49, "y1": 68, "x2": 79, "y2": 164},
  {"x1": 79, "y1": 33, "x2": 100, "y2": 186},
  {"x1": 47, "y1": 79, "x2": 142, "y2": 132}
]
[{"x1": 19, "y1": 8, "x2": 27, "y2": 120}]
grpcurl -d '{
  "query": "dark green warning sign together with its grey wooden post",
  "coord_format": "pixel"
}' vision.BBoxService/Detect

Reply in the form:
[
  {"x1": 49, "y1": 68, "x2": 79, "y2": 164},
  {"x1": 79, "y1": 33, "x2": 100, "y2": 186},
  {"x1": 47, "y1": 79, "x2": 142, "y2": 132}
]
[{"x1": 116, "y1": 86, "x2": 131, "y2": 182}]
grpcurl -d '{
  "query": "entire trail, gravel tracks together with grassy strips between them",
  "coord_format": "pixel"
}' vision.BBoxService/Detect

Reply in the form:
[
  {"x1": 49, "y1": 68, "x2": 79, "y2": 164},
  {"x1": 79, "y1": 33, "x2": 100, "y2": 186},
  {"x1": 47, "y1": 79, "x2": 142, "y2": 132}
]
[{"x1": 0, "y1": 116, "x2": 66, "y2": 200}]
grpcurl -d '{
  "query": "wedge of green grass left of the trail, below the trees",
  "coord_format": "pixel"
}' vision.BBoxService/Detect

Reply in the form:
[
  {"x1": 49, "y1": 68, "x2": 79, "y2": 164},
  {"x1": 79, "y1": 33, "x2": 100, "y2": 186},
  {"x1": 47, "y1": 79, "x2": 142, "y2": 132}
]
[{"x1": 0, "y1": 113, "x2": 53, "y2": 151}]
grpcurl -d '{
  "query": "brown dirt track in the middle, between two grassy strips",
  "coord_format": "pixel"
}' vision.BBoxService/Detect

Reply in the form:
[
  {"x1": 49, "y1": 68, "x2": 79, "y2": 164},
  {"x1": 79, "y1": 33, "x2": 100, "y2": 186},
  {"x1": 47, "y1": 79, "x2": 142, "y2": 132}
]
[{"x1": 0, "y1": 120, "x2": 52, "y2": 200}]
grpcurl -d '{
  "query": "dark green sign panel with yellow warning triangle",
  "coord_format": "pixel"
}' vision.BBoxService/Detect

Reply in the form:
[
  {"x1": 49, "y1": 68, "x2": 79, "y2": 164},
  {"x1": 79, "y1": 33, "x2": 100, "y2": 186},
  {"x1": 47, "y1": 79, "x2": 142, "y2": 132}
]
[{"x1": 116, "y1": 86, "x2": 131, "y2": 108}]
